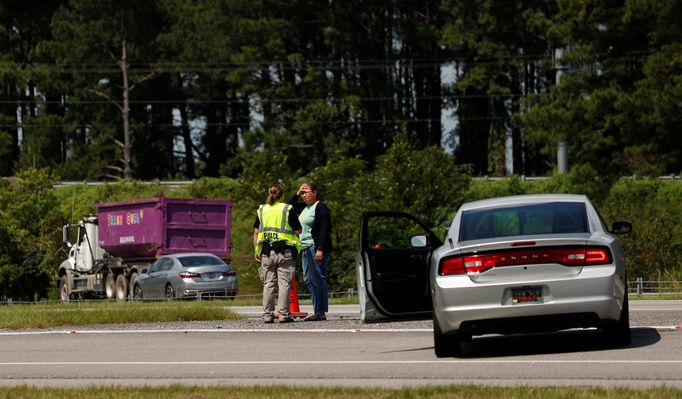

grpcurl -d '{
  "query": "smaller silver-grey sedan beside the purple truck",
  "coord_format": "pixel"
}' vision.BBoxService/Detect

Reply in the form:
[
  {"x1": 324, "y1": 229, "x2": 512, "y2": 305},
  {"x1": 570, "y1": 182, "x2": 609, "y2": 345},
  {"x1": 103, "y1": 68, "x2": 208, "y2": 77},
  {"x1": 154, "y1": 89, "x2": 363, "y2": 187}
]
[{"x1": 133, "y1": 252, "x2": 238, "y2": 299}]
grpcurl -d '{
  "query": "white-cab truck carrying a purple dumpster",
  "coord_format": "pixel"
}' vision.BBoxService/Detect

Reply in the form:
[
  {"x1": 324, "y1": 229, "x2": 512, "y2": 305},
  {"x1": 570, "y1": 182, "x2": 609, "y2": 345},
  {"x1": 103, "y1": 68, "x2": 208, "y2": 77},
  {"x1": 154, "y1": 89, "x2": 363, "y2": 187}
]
[{"x1": 57, "y1": 197, "x2": 232, "y2": 302}]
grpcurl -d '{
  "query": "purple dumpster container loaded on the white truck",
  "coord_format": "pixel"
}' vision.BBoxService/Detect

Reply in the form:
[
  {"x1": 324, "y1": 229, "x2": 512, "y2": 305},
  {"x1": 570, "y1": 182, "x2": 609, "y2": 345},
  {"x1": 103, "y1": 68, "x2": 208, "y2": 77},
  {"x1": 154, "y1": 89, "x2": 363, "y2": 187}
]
[{"x1": 95, "y1": 198, "x2": 232, "y2": 262}]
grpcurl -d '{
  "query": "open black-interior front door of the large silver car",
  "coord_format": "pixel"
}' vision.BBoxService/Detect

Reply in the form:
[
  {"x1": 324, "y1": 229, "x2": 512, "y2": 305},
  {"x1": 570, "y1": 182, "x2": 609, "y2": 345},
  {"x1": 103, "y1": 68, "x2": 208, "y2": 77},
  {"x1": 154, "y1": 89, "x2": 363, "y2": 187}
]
[{"x1": 357, "y1": 212, "x2": 442, "y2": 322}]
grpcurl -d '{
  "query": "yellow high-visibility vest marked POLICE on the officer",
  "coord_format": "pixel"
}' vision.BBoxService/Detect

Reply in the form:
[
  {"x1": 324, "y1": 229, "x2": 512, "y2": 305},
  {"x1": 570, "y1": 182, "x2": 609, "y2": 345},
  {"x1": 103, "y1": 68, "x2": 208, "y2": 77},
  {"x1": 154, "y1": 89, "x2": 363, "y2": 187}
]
[{"x1": 256, "y1": 202, "x2": 301, "y2": 255}]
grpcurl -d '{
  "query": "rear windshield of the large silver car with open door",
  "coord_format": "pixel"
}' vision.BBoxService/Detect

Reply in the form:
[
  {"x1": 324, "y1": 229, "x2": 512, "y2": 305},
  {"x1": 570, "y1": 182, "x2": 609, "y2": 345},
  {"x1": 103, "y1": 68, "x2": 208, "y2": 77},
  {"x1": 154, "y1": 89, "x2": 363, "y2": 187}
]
[{"x1": 459, "y1": 202, "x2": 588, "y2": 241}]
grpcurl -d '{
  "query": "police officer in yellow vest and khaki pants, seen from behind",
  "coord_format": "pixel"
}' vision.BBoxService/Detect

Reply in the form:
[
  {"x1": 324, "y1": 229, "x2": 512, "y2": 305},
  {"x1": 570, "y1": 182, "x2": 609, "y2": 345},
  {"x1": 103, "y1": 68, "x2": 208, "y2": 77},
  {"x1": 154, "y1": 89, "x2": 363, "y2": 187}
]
[{"x1": 253, "y1": 185, "x2": 301, "y2": 323}]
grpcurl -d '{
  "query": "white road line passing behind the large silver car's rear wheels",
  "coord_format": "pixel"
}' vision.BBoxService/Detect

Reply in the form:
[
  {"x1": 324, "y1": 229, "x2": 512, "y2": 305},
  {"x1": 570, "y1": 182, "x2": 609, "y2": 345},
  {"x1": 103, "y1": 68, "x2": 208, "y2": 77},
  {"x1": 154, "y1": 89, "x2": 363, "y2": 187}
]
[{"x1": 0, "y1": 325, "x2": 682, "y2": 336}]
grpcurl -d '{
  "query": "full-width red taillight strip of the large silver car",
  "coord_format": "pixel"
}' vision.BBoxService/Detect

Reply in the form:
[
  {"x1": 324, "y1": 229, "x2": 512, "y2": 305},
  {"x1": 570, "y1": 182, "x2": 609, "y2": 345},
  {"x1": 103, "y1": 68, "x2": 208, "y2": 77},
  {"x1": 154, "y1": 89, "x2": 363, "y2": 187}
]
[{"x1": 438, "y1": 247, "x2": 611, "y2": 276}]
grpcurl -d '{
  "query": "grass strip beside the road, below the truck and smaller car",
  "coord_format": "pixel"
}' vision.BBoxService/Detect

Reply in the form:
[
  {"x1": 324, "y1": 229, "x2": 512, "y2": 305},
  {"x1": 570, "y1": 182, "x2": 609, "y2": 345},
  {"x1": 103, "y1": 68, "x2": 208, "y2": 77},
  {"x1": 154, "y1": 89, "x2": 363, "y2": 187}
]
[{"x1": 0, "y1": 301, "x2": 239, "y2": 329}]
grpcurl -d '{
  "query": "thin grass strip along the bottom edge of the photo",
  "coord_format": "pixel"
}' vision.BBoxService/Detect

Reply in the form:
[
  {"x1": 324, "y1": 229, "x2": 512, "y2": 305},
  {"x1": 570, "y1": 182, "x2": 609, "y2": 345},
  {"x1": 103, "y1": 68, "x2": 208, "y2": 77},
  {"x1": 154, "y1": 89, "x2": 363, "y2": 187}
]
[{"x1": 0, "y1": 385, "x2": 682, "y2": 399}]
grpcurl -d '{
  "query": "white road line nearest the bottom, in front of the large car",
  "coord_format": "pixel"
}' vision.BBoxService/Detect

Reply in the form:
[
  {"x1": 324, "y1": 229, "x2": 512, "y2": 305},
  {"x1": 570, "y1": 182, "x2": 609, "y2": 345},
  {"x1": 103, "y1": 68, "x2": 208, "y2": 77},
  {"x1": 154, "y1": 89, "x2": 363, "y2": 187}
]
[{"x1": 0, "y1": 359, "x2": 682, "y2": 367}]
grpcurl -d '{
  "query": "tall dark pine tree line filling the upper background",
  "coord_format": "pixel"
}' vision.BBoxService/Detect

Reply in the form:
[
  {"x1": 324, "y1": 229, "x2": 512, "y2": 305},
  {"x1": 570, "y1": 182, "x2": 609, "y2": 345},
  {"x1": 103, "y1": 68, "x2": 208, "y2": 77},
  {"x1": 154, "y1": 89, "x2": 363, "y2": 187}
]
[{"x1": 0, "y1": 0, "x2": 682, "y2": 180}]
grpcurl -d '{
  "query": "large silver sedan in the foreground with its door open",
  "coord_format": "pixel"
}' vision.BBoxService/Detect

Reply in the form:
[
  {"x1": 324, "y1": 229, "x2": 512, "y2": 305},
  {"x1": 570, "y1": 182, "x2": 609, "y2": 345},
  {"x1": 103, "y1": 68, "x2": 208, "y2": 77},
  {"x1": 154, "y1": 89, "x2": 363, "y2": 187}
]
[{"x1": 358, "y1": 194, "x2": 632, "y2": 357}]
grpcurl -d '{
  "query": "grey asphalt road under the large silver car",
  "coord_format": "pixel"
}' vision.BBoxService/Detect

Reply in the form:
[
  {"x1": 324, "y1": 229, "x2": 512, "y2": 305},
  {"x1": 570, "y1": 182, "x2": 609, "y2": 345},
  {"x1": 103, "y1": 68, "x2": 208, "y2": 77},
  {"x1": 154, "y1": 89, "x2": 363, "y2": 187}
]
[{"x1": 0, "y1": 301, "x2": 682, "y2": 388}]
